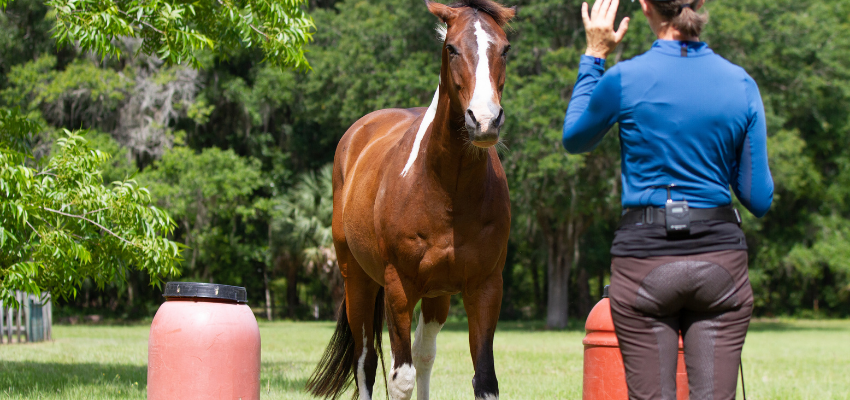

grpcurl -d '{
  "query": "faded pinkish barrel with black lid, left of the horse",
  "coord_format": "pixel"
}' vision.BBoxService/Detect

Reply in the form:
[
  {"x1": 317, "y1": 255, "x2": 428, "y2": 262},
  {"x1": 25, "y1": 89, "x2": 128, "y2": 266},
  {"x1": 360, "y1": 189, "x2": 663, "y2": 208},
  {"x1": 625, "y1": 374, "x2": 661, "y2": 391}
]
[{"x1": 148, "y1": 282, "x2": 260, "y2": 400}]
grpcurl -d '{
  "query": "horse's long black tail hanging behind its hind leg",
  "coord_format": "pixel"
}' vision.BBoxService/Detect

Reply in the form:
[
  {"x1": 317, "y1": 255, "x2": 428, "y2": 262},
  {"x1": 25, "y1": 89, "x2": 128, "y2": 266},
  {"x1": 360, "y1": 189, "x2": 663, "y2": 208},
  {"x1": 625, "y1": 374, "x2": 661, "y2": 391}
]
[{"x1": 306, "y1": 287, "x2": 387, "y2": 400}]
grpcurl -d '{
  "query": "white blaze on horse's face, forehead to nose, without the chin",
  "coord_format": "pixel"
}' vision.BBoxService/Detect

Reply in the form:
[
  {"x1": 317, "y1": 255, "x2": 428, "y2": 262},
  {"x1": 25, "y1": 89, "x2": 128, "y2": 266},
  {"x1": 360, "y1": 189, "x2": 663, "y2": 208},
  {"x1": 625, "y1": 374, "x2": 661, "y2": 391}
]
[{"x1": 469, "y1": 21, "x2": 499, "y2": 132}]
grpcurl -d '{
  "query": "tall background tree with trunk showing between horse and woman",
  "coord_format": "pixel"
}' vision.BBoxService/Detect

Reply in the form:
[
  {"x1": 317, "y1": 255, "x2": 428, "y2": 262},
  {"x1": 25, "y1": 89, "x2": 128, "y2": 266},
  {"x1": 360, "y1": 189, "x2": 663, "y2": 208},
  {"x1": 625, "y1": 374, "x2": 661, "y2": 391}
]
[{"x1": 503, "y1": 1, "x2": 619, "y2": 329}]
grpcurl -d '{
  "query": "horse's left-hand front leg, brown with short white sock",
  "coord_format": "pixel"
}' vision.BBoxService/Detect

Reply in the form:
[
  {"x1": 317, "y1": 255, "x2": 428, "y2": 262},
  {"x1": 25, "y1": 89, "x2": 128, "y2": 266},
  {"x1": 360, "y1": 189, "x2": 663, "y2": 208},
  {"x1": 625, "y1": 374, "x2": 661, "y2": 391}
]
[{"x1": 384, "y1": 266, "x2": 419, "y2": 400}]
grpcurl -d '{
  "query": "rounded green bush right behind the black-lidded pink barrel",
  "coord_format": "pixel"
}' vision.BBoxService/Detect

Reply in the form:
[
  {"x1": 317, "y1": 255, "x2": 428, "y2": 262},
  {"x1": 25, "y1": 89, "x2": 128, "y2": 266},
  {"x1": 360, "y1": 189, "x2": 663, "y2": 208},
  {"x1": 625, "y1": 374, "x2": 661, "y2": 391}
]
[{"x1": 139, "y1": 147, "x2": 265, "y2": 280}]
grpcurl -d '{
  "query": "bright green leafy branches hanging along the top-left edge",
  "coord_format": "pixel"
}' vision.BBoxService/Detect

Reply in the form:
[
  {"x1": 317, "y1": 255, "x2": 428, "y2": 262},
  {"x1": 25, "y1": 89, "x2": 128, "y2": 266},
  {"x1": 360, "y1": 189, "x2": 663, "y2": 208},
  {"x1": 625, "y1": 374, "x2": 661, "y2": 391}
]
[{"x1": 37, "y1": 0, "x2": 314, "y2": 68}]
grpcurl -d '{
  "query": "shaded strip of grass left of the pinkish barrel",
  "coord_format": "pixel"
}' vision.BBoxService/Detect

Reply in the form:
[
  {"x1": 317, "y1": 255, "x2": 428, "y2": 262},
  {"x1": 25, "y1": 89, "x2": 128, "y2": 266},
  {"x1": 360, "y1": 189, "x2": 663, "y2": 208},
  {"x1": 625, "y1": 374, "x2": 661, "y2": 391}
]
[{"x1": 0, "y1": 361, "x2": 148, "y2": 398}]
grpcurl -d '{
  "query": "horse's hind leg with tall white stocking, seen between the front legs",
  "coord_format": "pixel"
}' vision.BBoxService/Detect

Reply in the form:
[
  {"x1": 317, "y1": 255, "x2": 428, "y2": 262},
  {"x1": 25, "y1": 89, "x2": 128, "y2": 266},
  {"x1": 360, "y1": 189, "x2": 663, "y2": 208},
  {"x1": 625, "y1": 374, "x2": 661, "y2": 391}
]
[{"x1": 413, "y1": 296, "x2": 451, "y2": 400}]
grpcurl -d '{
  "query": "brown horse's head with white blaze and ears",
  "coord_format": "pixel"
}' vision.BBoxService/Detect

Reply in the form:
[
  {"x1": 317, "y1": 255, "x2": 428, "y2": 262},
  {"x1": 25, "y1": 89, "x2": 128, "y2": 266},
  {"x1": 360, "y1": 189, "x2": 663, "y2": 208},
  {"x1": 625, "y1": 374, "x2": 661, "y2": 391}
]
[{"x1": 425, "y1": 0, "x2": 516, "y2": 148}]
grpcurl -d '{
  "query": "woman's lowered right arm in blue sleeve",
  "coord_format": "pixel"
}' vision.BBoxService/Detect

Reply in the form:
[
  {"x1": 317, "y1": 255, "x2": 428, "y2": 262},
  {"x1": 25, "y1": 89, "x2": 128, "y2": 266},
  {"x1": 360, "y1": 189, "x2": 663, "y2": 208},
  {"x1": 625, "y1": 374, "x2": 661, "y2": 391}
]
[{"x1": 732, "y1": 76, "x2": 773, "y2": 218}]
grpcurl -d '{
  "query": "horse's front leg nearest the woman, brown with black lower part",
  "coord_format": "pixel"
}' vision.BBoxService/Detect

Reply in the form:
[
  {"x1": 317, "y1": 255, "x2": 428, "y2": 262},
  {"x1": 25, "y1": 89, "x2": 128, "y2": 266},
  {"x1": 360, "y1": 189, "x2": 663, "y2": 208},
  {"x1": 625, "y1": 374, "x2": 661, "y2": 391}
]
[{"x1": 463, "y1": 269, "x2": 502, "y2": 400}]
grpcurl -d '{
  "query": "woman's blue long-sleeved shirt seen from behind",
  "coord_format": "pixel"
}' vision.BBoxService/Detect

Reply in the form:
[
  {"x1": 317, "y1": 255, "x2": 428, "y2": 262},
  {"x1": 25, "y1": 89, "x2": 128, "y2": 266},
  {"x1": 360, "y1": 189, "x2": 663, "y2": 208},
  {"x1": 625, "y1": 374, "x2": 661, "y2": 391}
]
[{"x1": 563, "y1": 40, "x2": 773, "y2": 217}]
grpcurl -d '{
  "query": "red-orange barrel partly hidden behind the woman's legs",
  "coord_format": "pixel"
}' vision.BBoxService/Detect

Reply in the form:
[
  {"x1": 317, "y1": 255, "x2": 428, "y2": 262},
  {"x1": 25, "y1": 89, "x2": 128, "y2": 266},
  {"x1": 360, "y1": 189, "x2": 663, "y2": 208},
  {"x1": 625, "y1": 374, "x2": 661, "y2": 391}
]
[{"x1": 582, "y1": 286, "x2": 688, "y2": 400}]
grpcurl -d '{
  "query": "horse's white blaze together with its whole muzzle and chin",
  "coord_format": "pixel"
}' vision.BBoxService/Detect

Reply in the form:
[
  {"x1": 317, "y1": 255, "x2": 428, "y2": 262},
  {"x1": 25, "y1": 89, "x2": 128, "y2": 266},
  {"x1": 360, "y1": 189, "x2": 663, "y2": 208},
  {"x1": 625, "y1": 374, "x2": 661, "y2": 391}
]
[{"x1": 465, "y1": 20, "x2": 504, "y2": 147}]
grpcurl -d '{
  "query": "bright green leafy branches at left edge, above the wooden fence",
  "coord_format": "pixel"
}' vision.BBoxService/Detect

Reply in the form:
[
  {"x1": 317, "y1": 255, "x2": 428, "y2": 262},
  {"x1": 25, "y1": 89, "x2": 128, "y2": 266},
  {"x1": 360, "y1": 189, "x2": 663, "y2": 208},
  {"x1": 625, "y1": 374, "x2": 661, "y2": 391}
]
[{"x1": 0, "y1": 109, "x2": 180, "y2": 302}]
